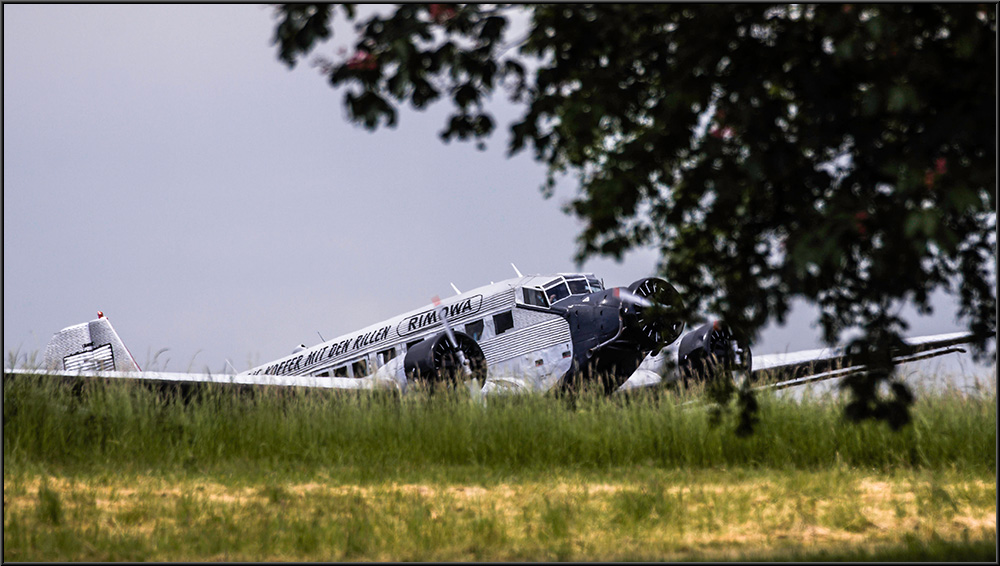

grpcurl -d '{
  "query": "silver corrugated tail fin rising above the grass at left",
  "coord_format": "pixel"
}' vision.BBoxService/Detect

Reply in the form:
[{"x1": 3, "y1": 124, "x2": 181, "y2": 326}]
[{"x1": 44, "y1": 311, "x2": 140, "y2": 371}]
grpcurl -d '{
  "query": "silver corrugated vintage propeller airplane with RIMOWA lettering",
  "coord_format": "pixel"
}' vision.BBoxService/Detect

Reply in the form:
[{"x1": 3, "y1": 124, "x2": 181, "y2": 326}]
[{"x1": 4, "y1": 265, "x2": 972, "y2": 394}]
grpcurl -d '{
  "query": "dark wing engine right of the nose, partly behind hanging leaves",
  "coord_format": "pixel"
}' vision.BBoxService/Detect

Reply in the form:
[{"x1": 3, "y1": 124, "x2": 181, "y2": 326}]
[{"x1": 677, "y1": 320, "x2": 753, "y2": 385}]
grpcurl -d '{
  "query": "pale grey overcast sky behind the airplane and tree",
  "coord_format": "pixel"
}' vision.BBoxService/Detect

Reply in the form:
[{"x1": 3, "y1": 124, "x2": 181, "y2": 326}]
[{"x1": 3, "y1": 4, "x2": 992, "y2": 382}]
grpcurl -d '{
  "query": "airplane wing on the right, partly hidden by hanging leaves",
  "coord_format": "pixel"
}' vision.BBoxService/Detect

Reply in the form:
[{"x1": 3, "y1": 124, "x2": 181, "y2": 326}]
[{"x1": 751, "y1": 332, "x2": 973, "y2": 389}]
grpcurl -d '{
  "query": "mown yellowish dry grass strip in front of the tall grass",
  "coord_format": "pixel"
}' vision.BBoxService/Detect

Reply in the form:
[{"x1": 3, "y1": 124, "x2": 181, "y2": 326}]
[{"x1": 4, "y1": 471, "x2": 996, "y2": 561}]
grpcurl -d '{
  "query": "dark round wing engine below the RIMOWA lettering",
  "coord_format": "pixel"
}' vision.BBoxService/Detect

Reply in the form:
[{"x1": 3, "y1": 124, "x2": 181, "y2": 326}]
[{"x1": 403, "y1": 332, "x2": 486, "y2": 390}]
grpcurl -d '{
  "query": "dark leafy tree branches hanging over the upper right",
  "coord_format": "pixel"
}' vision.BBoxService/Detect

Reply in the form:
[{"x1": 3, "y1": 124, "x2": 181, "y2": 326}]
[{"x1": 275, "y1": 4, "x2": 997, "y2": 430}]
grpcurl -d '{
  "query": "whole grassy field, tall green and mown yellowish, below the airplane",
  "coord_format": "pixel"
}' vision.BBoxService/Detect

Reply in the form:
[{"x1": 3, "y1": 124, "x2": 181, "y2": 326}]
[{"x1": 3, "y1": 372, "x2": 996, "y2": 561}]
